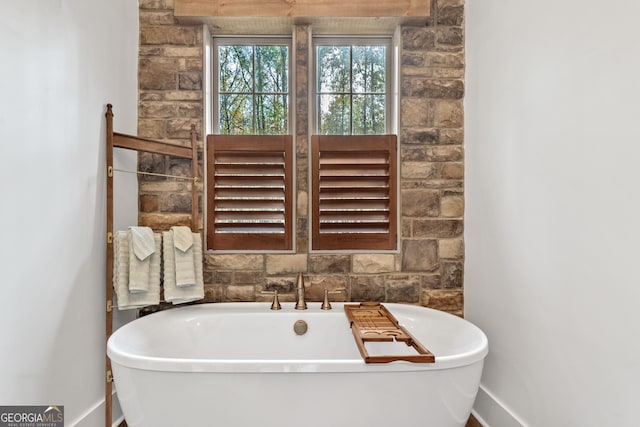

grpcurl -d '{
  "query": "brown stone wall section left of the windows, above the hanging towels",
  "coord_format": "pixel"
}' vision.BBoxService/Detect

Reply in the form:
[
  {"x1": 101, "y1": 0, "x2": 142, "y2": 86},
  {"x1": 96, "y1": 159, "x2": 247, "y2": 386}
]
[{"x1": 138, "y1": 0, "x2": 204, "y2": 234}]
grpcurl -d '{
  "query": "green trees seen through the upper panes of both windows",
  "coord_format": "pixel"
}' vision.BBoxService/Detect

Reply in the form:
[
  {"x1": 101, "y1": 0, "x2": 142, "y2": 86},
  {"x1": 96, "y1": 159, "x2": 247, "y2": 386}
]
[{"x1": 217, "y1": 41, "x2": 389, "y2": 135}]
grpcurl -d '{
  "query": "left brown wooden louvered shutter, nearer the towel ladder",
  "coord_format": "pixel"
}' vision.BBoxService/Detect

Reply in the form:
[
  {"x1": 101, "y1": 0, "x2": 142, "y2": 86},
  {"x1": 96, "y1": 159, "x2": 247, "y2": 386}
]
[{"x1": 207, "y1": 135, "x2": 293, "y2": 250}]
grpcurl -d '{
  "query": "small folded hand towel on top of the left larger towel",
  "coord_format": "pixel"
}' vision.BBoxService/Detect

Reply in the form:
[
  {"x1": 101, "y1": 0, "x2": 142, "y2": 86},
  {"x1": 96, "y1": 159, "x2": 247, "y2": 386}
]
[{"x1": 127, "y1": 227, "x2": 160, "y2": 293}]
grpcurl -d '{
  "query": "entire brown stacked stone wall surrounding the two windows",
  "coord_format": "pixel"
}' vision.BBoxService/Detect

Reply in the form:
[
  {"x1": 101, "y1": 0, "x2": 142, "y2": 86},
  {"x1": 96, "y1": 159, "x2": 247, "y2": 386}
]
[{"x1": 138, "y1": 0, "x2": 464, "y2": 314}]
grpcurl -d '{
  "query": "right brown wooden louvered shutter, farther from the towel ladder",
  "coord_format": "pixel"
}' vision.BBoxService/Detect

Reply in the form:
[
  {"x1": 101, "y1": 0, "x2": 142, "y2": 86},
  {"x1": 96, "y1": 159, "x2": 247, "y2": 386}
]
[{"x1": 311, "y1": 135, "x2": 397, "y2": 250}]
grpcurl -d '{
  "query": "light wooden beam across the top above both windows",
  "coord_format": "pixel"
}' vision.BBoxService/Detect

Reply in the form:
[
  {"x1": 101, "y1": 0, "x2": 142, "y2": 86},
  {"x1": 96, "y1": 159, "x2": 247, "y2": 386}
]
[{"x1": 174, "y1": 0, "x2": 431, "y2": 18}]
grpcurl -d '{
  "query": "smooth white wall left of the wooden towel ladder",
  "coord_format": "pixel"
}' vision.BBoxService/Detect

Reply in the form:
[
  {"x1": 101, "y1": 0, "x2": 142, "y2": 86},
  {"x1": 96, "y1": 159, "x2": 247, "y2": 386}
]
[{"x1": 0, "y1": 0, "x2": 138, "y2": 427}]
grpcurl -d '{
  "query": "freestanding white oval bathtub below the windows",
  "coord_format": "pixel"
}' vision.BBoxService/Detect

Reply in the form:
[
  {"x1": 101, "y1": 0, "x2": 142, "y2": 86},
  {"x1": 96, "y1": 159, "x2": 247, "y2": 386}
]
[{"x1": 107, "y1": 303, "x2": 488, "y2": 427}]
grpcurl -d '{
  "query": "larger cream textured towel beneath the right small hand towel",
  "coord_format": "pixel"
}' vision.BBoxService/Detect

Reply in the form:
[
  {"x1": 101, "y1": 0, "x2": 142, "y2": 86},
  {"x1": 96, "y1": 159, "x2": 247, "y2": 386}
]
[{"x1": 162, "y1": 231, "x2": 204, "y2": 304}]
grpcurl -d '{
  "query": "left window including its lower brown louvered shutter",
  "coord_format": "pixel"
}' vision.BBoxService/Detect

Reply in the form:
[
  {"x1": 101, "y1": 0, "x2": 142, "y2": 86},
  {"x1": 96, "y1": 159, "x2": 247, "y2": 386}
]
[{"x1": 206, "y1": 37, "x2": 294, "y2": 250}]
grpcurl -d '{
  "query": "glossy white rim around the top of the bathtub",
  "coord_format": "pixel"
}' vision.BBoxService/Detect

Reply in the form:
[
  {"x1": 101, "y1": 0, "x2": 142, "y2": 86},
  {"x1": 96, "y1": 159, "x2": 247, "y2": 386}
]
[{"x1": 107, "y1": 302, "x2": 489, "y2": 373}]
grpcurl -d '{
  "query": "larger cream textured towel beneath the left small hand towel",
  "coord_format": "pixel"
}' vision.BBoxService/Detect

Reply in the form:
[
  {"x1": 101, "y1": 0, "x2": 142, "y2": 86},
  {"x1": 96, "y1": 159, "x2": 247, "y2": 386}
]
[{"x1": 113, "y1": 231, "x2": 162, "y2": 310}]
